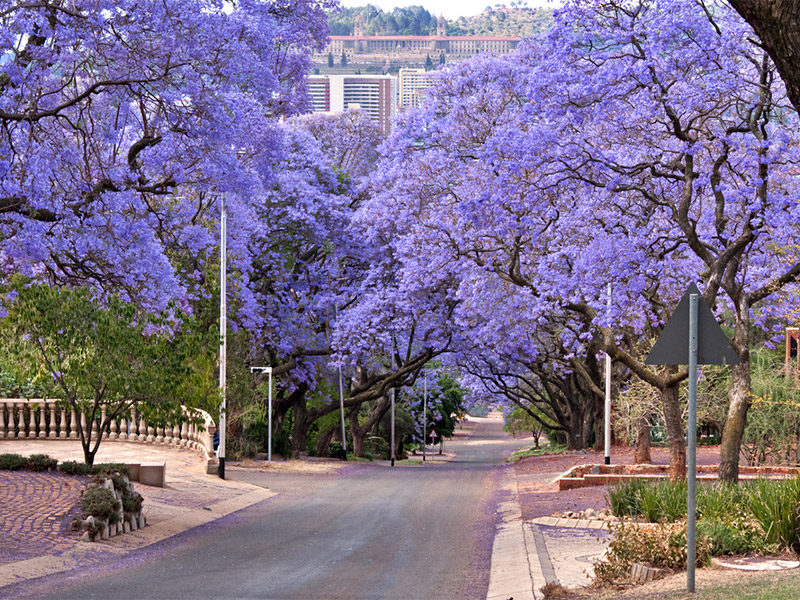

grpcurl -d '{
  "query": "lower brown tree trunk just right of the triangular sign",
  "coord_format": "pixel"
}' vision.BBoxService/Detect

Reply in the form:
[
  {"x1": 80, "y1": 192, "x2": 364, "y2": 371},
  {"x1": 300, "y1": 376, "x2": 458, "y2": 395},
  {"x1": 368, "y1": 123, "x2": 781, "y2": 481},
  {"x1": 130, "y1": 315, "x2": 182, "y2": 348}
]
[{"x1": 719, "y1": 355, "x2": 750, "y2": 483}]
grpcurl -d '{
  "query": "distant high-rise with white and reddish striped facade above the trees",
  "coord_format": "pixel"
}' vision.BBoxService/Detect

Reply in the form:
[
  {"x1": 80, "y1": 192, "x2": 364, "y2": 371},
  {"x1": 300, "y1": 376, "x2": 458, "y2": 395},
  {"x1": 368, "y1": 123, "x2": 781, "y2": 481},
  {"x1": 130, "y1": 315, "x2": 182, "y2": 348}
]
[{"x1": 308, "y1": 75, "x2": 397, "y2": 133}]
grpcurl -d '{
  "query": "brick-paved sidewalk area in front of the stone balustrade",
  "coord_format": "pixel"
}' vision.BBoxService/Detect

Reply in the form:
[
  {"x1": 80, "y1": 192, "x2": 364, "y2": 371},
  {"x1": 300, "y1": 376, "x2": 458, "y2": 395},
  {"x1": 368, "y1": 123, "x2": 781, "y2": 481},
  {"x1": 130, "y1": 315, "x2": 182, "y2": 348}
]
[{"x1": 0, "y1": 440, "x2": 275, "y2": 589}]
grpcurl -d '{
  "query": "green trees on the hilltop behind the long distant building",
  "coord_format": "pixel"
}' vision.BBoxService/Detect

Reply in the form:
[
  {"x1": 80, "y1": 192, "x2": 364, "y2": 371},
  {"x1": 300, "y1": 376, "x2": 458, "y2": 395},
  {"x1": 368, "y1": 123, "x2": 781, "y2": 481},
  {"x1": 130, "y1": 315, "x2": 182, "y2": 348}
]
[{"x1": 328, "y1": 4, "x2": 553, "y2": 37}]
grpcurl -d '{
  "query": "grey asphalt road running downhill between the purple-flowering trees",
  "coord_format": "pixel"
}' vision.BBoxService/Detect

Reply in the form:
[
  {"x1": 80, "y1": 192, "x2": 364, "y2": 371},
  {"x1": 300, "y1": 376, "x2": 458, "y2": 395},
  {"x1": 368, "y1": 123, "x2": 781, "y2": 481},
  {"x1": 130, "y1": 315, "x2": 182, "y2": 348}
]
[{"x1": 29, "y1": 420, "x2": 521, "y2": 600}]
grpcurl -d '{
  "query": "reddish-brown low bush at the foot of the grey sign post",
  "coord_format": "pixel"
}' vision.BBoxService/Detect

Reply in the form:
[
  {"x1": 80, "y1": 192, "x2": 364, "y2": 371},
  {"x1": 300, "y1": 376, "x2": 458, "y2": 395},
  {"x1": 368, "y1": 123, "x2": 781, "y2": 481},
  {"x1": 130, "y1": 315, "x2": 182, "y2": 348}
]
[{"x1": 595, "y1": 522, "x2": 711, "y2": 582}]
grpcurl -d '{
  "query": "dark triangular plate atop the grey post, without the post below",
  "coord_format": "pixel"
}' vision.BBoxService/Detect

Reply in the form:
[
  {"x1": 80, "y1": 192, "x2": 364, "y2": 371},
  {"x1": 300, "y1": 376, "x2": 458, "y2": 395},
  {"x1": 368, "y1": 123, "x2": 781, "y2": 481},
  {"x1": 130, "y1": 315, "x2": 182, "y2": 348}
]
[{"x1": 644, "y1": 283, "x2": 739, "y2": 365}]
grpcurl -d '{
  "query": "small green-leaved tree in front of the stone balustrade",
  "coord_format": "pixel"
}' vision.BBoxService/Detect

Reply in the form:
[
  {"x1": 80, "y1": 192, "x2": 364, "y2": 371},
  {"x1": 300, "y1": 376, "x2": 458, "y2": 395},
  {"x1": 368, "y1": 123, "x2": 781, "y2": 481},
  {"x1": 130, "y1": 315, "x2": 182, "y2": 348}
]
[{"x1": 3, "y1": 279, "x2": 200, "y2": 465}]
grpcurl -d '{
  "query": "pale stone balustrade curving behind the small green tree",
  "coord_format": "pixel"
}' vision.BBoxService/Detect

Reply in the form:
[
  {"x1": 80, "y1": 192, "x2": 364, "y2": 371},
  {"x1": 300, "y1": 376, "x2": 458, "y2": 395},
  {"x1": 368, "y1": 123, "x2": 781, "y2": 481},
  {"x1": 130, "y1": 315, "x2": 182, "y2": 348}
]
[{"x1": 0, "y1": 398, "x2": 216, "y2": 460}]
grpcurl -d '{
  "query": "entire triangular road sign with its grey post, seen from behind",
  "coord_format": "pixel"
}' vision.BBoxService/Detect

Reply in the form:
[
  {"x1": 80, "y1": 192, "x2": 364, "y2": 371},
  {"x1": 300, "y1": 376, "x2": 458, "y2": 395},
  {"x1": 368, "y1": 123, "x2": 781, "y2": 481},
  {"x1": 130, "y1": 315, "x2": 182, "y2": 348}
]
[{"x1": 645, "y1": 283, "x2": 739, "y2": 593}]
